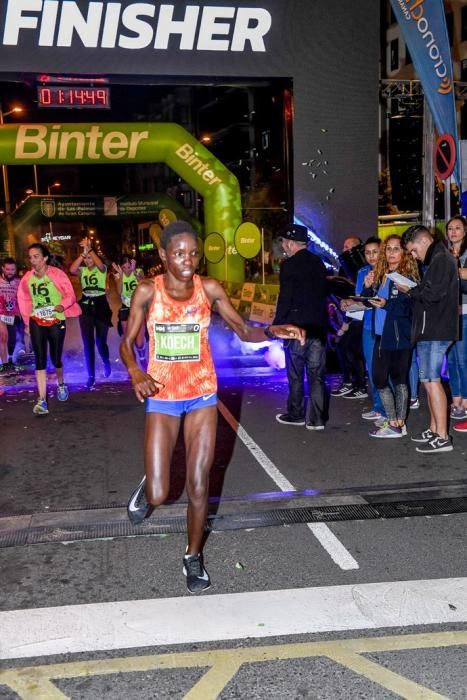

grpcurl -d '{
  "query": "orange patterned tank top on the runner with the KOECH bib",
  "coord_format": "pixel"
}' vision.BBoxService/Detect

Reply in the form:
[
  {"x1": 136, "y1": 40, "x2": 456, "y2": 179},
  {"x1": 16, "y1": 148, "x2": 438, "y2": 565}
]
[{"x1": 146, "y1": 275, "x2": 217, "y2": 401}]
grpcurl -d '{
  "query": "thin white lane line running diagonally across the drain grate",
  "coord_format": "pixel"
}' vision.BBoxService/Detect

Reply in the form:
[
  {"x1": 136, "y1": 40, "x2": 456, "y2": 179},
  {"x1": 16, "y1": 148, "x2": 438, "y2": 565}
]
[{"x1": 217, "y1": 401, "x2": 359, "y2": 571}]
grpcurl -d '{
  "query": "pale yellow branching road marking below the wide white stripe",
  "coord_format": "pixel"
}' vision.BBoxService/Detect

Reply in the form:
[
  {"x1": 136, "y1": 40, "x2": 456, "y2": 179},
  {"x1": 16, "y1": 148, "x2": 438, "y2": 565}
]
[{"x1": 0, "y1": 631, "x2": 467, "y2": 700}]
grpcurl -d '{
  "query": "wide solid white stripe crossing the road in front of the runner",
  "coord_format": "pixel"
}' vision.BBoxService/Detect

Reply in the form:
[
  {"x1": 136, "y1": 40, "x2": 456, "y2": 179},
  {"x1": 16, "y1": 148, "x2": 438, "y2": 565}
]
[{"x1": 0, "y1": 578, "x2": 467, "y2": 659}]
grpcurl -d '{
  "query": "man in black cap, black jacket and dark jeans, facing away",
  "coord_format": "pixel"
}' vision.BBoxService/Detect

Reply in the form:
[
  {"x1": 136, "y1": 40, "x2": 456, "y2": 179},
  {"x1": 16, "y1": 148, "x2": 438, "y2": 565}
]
[{"x1": 274, "y1": 224, "x2": 328, "y2": 430}]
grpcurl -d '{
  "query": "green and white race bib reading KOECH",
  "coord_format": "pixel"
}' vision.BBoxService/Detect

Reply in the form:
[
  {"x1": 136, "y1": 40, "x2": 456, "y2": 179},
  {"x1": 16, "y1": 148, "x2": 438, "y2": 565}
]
[{"x1": 154, "y1": 323, "x2": 201, "y2": 362}]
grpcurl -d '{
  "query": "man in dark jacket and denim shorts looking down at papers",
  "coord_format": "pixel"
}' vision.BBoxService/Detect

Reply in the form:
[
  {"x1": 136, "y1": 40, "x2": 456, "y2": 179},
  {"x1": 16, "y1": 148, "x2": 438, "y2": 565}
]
[{"x1": 398, "y1": 226, "x2": 459, "y2": 454}]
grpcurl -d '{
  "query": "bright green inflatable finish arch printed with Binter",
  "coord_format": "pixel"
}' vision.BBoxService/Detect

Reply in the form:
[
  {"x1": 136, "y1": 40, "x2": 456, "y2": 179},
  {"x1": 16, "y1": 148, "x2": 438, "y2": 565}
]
[{"x1": 0, "y1": 122, "x2": 244, "y2": 282}]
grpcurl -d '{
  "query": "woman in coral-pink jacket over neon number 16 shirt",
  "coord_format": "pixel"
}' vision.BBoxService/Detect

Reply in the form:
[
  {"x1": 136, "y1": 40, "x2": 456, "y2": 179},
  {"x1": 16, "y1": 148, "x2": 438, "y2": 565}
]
[{"x1": 18, "y1": 243, "x2": 81, "y2": 416}]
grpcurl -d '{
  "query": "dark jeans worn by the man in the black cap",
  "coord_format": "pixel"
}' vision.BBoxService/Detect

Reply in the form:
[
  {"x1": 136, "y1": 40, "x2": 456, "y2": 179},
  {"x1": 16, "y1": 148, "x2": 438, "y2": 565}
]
[{"x1": 284, "y1": 338, "x2": 327, "y2": 425}]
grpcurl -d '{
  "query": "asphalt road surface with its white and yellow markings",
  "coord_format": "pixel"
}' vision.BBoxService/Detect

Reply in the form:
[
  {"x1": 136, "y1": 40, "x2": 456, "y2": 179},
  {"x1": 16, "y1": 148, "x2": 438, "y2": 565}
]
[{"x1": 0, "y1": 322, "x2": 467, "y2": 700}]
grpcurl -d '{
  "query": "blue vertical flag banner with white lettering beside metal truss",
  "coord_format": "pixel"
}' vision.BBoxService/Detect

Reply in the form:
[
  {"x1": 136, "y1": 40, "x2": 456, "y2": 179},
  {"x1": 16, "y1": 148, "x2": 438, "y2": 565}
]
[{"x1": 391, "y1": 0, "x2": 461, "y2": 186}]
